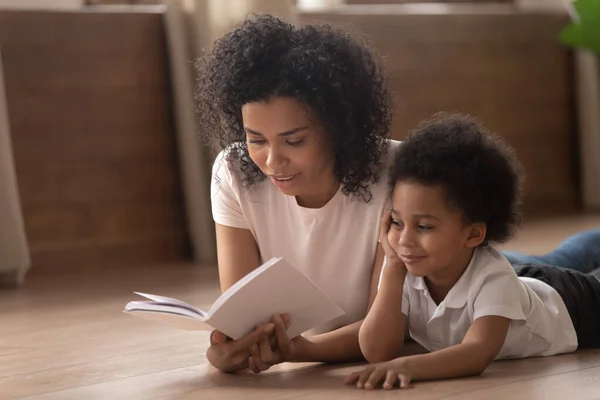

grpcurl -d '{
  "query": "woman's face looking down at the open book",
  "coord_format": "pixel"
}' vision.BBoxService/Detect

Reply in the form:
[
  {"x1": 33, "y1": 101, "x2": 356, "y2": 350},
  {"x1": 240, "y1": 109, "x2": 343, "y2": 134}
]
[{"x1": 242, "y1": 97, "x2": 339, "y2": 208}]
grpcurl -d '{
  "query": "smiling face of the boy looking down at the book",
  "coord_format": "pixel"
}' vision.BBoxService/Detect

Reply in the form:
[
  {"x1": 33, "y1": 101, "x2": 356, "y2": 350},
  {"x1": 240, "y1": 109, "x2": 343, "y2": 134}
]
[{"x1": 388, "y1": 181, "x2": 485, "y2": 277}]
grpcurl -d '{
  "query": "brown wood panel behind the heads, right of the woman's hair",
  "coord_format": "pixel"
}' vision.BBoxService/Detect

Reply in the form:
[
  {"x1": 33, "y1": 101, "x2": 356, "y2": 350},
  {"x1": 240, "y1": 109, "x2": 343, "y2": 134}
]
[{"x1": 301, "y1": 5, "x2": 579, "y2": 213}]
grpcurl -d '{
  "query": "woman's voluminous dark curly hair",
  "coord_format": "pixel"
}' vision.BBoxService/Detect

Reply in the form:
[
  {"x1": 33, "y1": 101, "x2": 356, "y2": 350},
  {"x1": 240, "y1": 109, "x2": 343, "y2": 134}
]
[{"x1": 195, "y1": 15, "x2": 393, "y2": 202}]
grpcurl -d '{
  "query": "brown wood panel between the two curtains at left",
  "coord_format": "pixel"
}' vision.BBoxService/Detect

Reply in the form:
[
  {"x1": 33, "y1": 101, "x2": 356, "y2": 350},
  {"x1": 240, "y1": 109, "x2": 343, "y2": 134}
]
[{"x1": 0, "y1": 11, "x2": 187, "y2": 268}]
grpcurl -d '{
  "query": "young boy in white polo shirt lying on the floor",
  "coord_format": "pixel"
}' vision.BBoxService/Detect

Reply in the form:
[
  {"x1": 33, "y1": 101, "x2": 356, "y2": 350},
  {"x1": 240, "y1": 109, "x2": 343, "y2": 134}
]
[{"x1": 346, "y1": 114, "x2": 600, "y2": 389}]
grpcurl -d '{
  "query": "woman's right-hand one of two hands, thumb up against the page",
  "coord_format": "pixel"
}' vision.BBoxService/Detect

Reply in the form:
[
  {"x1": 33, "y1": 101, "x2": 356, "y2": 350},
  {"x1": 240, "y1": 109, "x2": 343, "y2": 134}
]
[{"x1": 248, "y1": 314, "x2": 308, "y2": 374}]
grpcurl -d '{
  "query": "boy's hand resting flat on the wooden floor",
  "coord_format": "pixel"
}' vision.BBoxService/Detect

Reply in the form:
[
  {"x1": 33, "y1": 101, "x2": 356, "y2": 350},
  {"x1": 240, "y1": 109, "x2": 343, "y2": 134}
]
[{"x1": 345, "y1": 358, "x2": 413, "y2": 389}]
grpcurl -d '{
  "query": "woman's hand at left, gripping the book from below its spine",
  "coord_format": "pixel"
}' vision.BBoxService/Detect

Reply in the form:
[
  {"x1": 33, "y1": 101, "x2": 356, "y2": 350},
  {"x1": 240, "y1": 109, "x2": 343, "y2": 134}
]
[{"x1": 206, "y1": 323, "x2": 275, "y2": 372}]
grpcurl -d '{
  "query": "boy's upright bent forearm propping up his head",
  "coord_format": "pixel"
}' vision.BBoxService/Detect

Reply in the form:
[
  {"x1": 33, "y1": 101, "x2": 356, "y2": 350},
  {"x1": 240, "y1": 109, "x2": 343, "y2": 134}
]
[{"x1": 358, "y1": 261, "x2": 407, "y2": 363}]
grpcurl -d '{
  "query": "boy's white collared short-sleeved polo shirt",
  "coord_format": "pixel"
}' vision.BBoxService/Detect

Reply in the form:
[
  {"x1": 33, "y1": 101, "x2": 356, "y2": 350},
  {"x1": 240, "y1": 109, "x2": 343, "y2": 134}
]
[{"x1": 402, "y1": 246, "x2": 577, "y2": 359}]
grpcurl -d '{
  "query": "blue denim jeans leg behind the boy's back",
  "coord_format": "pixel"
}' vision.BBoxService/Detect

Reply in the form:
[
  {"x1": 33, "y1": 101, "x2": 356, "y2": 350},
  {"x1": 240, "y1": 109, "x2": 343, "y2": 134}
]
[{"x1": 503, "y1": 229, "x2": 600, "y2": 274}]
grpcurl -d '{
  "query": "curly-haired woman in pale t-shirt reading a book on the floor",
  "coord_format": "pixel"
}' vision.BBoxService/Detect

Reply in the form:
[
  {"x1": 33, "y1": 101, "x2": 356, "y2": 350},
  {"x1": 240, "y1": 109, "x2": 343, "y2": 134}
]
[{"x1": 196, "y1": 16, "x2": 596, "y2": 373}]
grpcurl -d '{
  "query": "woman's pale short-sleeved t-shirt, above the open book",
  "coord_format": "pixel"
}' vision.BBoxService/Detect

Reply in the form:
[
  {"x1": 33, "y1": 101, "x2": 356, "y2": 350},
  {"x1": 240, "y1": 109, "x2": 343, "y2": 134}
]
[{"x1": 211, "y1": 141, "x2": 400, "y2": 333}]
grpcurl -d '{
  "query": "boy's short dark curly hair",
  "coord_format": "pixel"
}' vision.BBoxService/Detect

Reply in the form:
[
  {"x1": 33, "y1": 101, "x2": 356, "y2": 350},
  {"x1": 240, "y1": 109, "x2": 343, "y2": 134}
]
[{"x1": 390, "y1": 113, "x2": 523, "y2": 244}]
